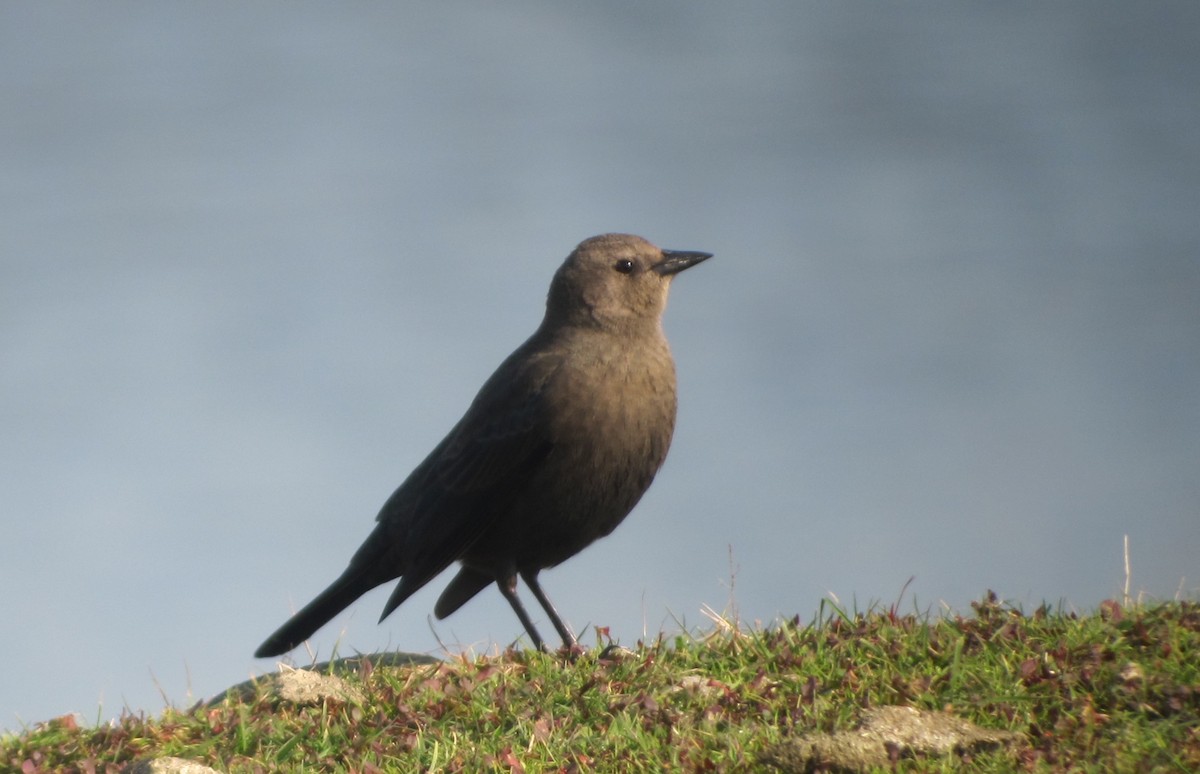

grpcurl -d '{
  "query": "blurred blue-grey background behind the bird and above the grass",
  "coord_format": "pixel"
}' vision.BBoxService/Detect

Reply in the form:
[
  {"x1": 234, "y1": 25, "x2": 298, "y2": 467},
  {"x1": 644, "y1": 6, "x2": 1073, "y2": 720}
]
[{"x1": 0, "y1": 0, "x2": 1200, "y2": 730}]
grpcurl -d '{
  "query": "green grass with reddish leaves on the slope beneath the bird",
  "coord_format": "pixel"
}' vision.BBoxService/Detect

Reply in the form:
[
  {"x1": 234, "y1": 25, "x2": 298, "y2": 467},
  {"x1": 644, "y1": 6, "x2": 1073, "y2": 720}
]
[{"x1": 0, "y1": 595, "x2": 1200, "y2": 772}]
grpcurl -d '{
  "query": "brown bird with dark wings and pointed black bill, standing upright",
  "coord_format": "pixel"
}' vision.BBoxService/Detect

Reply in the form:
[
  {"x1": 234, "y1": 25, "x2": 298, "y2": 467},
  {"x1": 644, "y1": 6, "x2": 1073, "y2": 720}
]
[{"x1": 254, "y1": 234, "x2": 712, "y2": 658}]
